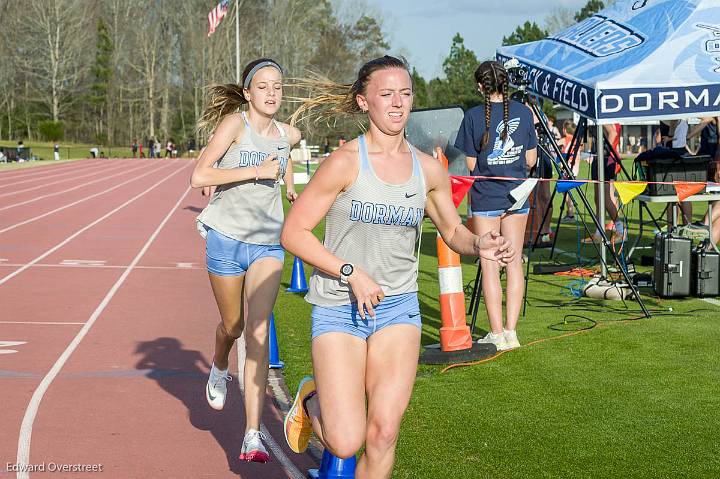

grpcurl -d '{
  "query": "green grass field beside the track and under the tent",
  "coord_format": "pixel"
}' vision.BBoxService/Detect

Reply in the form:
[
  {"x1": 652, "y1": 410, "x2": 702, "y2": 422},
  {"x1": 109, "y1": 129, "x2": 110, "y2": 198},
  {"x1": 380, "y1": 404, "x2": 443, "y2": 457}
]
[{"x1": 275, "y1": 162, "x2": 720, "y2": 479}]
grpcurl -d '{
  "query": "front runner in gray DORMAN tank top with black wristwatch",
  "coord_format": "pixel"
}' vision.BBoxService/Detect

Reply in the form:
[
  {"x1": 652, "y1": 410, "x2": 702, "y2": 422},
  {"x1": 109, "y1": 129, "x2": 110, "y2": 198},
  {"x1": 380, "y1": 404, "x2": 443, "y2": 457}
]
[{"x1": 281, "y1": 56, "x2": 516, "y2": 479}]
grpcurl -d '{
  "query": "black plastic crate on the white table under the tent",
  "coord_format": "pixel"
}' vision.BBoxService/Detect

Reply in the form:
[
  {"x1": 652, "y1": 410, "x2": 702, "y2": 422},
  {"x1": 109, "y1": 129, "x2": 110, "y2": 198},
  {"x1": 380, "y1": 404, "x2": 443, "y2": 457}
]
[{"x1": 647, "y1": 156, "x2": 710, "y2": 196}]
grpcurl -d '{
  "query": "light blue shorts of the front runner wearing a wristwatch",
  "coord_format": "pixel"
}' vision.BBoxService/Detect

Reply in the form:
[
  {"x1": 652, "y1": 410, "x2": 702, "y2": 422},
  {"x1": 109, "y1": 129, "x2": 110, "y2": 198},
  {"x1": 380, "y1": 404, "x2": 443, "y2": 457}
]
[{"x1": 312, "y1": 293, "x2": 422, "y2": 341}]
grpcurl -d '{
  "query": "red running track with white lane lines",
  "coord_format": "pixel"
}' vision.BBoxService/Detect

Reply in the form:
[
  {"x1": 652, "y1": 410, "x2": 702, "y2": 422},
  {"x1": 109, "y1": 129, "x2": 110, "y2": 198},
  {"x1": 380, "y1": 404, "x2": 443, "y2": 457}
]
[{"x1": 0, "y1": 159, "x2": 315, "y2": 479}]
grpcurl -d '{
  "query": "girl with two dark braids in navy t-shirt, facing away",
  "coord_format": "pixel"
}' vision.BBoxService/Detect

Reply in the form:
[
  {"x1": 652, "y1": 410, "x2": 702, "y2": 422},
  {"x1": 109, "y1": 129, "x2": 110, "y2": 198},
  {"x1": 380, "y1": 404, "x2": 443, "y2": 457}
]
[{"x1": 455, "y1": 61, "x2": 537, "y2": 350}]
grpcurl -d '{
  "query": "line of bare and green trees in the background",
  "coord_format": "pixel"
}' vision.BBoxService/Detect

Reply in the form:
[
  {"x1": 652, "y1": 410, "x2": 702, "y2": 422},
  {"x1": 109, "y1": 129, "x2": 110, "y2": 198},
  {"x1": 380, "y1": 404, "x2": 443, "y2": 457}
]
[{"x1": 0, "y1": 0, "x2": 604, "y2": 145}]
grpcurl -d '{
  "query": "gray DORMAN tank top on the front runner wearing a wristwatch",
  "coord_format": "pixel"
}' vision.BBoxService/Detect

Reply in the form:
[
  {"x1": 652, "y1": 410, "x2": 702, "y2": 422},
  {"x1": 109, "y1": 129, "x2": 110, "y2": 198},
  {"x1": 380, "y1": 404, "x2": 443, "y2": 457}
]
[{"x1": 305, "y1": 135, "x2": 426, "y2": 306}]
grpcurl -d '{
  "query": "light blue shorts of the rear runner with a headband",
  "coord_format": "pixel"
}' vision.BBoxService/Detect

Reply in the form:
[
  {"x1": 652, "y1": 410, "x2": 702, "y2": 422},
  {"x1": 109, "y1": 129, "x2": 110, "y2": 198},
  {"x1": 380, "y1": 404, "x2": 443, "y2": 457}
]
[{"x1": 205, "y1": 227, "x2": 285, "y2": 276}]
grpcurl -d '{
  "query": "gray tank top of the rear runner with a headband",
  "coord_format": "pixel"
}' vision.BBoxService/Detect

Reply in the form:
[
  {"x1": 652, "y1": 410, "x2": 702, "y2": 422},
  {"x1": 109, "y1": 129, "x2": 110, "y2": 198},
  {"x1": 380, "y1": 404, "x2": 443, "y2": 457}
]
[{"x1": 197, "y1": 112, "x2": 290, "y2": 245}]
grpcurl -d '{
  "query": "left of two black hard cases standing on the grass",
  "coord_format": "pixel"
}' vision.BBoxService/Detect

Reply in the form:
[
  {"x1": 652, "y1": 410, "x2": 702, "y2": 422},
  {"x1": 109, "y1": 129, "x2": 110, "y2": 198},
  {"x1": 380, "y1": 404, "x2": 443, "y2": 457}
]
[{"x1": 653, "y1": 231, "x2": 692, "y2": 298}]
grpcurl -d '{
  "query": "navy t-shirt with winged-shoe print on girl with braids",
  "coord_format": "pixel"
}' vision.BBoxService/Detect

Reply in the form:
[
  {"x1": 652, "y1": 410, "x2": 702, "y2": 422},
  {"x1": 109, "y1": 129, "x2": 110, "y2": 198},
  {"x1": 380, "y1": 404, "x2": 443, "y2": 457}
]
[{"x1": 455, "y1": 100, "x2": 537, "y2": 211}]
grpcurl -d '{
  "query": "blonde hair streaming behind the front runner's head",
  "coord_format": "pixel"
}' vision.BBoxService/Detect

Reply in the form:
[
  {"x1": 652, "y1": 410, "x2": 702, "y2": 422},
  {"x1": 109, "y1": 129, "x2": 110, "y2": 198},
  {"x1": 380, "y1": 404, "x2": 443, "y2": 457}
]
[{"x1": 288, "y1": 55, "x2": 409, "y2": 125}]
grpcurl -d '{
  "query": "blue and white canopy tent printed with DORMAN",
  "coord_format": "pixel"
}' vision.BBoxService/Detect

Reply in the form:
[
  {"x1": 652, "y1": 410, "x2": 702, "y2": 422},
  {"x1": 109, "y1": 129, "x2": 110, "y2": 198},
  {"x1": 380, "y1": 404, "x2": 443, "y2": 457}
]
[{"x1": 497, "y1": 0, "x2": 720, "y2": 270}]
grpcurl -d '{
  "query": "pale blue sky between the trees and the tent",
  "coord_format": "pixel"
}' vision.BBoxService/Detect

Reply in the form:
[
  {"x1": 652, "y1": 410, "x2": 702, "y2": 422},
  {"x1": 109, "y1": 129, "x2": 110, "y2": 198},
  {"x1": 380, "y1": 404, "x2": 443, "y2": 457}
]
[{"x1": 365, "y1": 0, "x2": 587, "y2": 80}]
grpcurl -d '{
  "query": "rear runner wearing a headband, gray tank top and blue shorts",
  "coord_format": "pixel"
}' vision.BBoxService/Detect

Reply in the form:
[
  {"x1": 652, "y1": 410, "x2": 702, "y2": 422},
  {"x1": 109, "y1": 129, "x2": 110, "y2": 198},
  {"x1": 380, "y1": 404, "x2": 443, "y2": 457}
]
[{"x1": 191, "y1": 58, "x2": 300, "y2": 462}]
